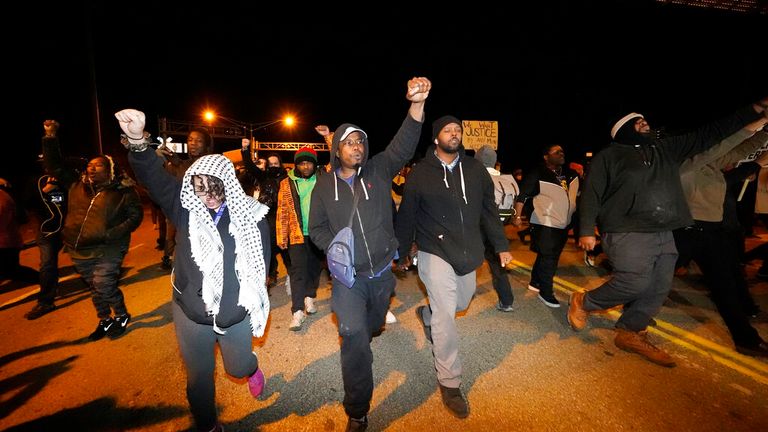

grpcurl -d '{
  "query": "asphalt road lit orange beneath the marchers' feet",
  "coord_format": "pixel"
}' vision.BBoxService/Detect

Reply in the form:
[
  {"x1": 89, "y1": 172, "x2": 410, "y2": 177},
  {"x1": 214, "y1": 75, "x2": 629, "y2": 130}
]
[{"x1": 0, "y1": 213, "x2": 768, "y2": 432}]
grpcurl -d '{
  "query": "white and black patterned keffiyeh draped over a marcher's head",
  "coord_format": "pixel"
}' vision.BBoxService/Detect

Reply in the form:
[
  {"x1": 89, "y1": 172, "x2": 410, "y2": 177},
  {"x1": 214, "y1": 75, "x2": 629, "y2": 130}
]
[{"x1": 181, "y1": 154, "x2": 269, "y2": 337}]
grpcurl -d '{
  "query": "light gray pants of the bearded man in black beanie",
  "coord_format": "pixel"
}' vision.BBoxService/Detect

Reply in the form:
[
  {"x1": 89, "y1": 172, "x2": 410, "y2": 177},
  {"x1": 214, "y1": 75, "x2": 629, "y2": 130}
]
[{"x1": 418, "y1": 251, "x2": 477, "y2": 388}]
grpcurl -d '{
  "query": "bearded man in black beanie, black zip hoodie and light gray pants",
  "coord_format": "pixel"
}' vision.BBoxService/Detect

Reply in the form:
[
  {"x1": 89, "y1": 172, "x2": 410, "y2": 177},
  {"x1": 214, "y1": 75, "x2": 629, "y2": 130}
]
[{"x1": 396, "y1": 116, "x2": 512, "y2": 418}]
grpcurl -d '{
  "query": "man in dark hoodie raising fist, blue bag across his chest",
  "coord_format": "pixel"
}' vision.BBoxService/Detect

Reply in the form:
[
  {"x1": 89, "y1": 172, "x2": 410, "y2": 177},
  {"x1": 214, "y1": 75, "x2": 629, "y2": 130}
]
[{"x1": 309, "y1": 78, "x2": 432, "y2": 431}]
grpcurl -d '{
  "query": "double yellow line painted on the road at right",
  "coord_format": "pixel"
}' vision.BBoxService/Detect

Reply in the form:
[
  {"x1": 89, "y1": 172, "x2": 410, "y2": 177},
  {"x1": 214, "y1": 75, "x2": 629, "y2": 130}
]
[{"x1": 508, "y1": 260, "x2": 768, "y2": 385}]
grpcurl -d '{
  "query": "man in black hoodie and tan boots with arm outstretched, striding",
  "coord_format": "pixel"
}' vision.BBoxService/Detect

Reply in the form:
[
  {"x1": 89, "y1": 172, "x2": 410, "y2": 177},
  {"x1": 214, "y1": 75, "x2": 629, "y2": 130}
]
[{"x1": 568, "y1": 100, "x2": 768, "y2": 367}]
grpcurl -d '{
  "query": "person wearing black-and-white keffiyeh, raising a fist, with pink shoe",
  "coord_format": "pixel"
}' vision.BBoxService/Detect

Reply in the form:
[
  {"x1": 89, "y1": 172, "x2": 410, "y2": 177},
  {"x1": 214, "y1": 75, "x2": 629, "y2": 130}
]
[{"x1": 115, "y1": 109, "x2": 270, "y2": 431}]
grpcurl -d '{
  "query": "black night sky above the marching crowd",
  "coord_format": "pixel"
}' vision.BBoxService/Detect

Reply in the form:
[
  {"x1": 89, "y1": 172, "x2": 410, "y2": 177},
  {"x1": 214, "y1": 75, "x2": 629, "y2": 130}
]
[{"x1": 10, "y1": 0, "x2": 768, "y2": 187}]
